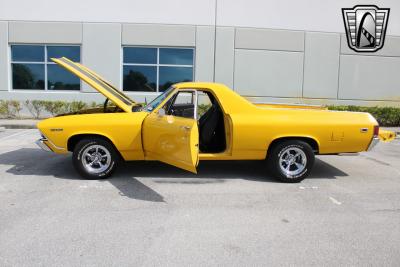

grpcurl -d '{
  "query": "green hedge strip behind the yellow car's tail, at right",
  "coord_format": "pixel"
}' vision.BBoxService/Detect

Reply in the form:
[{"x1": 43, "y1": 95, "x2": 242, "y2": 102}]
[{"x1": 328, "y1": 106, "x2": 400, "y2": 127}]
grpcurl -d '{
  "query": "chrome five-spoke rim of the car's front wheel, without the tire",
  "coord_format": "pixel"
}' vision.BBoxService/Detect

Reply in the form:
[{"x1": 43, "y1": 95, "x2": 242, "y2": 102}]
[{"x1": 81, "y1": 145, "x2": 111, "y2": 174}]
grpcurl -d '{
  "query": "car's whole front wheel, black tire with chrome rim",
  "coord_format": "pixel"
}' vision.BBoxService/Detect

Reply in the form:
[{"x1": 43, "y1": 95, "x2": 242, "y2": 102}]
[{"x1": 72, "y1": 138, "x2": 119, "y2": 180}]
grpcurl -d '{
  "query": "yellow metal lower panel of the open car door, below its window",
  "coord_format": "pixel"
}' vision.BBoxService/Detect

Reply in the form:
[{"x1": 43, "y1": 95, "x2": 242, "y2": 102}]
[{"x1": 142, "y1": 112, "x2": 199, "y2": 173}]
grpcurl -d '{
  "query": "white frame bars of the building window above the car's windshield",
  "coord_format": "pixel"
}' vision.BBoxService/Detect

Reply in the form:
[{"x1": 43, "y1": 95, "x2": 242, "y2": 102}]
[{"x1": 121, "y1": 45, "x2": 196, "y2": 94}]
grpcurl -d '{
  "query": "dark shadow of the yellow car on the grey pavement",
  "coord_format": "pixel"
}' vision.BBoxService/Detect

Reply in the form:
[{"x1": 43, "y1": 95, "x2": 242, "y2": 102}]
[{"x1": 0, "y1": 148, "x2": 348, "y2": 202}]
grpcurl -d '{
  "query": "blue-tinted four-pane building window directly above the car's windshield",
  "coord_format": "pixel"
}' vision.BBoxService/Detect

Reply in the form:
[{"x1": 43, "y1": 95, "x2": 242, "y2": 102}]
[{"x1": 123, "y1": 47, "x2": 194, "y2": 92}]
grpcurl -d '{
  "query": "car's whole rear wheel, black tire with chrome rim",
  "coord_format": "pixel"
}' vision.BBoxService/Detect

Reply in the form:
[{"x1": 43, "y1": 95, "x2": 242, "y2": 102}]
[{"x1": 267, "y1": 140, "x2": 315, "y2": 183}]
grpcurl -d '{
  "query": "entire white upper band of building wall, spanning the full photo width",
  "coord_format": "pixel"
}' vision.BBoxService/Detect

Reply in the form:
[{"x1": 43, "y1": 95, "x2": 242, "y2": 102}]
[{"x1": 0, "y1": 0, "x2": 400, "y2": 36}]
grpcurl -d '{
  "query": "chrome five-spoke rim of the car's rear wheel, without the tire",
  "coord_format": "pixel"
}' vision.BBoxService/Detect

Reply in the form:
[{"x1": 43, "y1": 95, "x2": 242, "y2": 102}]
[{"x1": 279, "y1": 147, "x2": 307, "y2": 177}]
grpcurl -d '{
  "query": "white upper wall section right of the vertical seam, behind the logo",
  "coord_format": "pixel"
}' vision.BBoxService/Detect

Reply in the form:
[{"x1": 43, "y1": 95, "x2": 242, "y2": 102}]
[{"x1": 217, "y1": 0, "x2": 400, "y2": 36}]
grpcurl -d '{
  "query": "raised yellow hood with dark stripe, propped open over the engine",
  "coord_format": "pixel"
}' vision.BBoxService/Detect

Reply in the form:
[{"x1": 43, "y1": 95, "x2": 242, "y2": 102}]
[{"x1": 51, "y1": 57, "x2": 135, "y2": 112}]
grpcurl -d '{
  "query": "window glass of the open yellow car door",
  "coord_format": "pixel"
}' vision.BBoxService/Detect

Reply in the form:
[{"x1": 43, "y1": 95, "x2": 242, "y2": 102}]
[{"x1": 164, "y1": 91, "x2": 195, "y2": 118}]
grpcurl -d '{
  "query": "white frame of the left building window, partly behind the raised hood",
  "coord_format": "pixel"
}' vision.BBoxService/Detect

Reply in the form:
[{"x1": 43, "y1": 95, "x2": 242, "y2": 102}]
[{"x1": 8, "y1": 43, "x2": 82, "y2": 93}]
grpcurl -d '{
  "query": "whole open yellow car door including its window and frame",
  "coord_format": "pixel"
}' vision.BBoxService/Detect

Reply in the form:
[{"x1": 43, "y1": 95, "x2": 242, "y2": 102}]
[{"x1": 142, "y1": 90, "x2": 199, "y2": 173}]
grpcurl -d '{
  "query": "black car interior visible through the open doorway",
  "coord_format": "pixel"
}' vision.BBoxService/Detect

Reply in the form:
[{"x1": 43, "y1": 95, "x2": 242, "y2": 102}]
[{"x1": 199, "y1": 92, "x2": 226, "y2": 153}]
